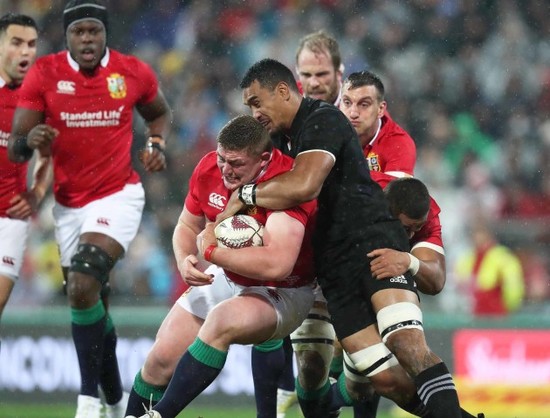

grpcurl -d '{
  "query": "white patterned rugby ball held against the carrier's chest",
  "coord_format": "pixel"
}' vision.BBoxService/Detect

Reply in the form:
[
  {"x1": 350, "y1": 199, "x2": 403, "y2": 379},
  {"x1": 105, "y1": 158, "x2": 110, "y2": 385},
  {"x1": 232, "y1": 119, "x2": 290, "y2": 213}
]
[{"x1": 214, "y1": 215, "x2": 264, "y2": 249}]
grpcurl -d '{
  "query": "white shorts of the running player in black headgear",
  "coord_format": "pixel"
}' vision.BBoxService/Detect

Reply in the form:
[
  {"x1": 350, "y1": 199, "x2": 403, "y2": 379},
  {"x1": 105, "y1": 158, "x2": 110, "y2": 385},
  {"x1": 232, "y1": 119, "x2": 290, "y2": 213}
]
[{"x1": 53, "y1": 183, "x2": 145, "y2": 267}]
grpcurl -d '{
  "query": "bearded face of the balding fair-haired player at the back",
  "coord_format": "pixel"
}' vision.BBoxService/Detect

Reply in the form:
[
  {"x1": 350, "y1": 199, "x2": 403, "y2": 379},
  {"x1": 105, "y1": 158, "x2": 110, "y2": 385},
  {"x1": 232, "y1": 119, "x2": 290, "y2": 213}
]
[{"x1": 296, "y1": 49, "x2": 342, "y2": 103}]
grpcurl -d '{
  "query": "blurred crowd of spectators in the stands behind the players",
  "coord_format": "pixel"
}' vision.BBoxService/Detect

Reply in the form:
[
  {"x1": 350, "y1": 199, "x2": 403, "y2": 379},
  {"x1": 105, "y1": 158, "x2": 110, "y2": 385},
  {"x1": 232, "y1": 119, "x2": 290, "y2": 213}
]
[{"x1": 4, "y1": 0, "x2": 550, "y2": 312}]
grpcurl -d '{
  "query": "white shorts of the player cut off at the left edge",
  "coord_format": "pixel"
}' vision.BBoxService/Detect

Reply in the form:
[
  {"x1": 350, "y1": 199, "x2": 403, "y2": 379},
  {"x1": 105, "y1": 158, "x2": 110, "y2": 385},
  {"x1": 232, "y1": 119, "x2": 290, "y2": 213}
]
[{"x1": 0, "y1": 218, "x2": 29, "y2": 280}]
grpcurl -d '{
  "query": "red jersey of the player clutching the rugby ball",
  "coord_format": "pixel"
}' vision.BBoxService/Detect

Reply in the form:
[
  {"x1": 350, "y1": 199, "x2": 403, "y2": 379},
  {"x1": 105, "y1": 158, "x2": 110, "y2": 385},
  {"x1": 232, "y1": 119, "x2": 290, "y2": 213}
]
[{"x1": 185, "y1": 149, "x2": 317, "y2": 287}]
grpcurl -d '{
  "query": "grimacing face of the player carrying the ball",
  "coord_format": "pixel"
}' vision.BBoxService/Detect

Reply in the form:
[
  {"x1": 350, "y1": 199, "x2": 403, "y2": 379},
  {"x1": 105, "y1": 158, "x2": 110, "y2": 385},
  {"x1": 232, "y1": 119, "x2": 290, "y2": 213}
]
[{"x1": 216, "y1": 145, "x2": 269, "y2": 191}]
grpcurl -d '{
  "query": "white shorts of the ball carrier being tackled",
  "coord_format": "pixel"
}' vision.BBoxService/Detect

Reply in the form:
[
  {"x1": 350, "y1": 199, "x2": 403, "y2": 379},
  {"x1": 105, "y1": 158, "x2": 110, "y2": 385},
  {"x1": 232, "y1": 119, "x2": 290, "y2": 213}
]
[{"x1": 177, "y1": 265, "x2": 315, "y2": 340}]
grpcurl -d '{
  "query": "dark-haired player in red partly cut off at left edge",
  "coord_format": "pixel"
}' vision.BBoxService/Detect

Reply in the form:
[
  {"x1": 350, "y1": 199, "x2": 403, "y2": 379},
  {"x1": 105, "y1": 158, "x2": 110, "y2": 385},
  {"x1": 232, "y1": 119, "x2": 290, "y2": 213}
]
[{"x1": 0, "y1": 13, "x2": 51, "y2": 356}]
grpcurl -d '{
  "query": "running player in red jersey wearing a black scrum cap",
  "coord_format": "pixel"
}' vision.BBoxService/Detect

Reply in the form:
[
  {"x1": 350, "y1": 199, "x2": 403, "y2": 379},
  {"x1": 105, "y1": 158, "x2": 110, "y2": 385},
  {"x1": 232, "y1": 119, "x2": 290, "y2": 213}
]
[{"x1": 9, "y1": 0, "x2": 171, "y2": 418}]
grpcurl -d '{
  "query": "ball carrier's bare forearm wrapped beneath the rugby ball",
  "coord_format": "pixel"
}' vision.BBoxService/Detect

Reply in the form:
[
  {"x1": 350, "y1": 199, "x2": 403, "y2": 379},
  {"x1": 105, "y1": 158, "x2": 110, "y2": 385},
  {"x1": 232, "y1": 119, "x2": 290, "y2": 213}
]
[{"x1": 211, "y1": 247, "x2": 296, "y2": 281}]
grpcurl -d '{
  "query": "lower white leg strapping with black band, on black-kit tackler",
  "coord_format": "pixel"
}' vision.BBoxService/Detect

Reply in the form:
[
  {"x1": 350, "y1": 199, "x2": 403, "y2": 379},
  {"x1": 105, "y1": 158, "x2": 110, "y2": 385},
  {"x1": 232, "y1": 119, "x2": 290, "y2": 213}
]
[{"x1": 344, "y1": 343, "x2": 399, "y2": 383}]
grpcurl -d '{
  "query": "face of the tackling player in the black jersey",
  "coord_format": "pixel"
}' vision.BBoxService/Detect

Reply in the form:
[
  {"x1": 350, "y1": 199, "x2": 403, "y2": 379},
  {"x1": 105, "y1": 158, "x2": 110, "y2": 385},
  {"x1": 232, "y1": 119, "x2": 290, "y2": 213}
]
[{"x1": 243, "y1": 81, "x2": 294, "y2": 134}]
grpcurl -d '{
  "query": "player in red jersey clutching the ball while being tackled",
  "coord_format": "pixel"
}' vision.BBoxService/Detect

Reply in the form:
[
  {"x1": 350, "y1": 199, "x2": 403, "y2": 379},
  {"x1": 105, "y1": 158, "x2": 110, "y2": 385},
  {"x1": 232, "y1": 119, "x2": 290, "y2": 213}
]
[{"x1": 123, "y1": 115, "x2": 316, "y2": 418}]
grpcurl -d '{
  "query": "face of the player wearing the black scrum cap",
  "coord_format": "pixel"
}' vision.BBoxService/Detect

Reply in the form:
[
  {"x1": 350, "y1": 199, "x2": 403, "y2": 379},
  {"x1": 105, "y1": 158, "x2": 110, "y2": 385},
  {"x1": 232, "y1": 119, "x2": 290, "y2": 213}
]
[{"x1": 67, "y1": 20, "x2": 107, "y2": 71}]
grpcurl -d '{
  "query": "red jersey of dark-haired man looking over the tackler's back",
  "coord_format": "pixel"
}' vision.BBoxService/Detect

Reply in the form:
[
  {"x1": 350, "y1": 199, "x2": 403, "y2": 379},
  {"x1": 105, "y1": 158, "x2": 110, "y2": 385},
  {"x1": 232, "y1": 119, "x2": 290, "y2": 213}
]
[{"x1": 363, "y1": 111, "x2": 416, "y2": 177}]
